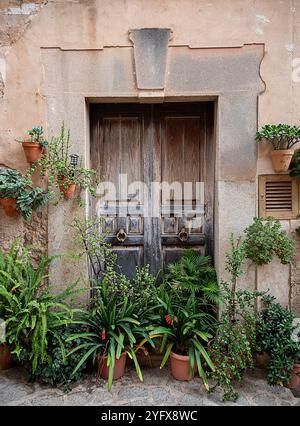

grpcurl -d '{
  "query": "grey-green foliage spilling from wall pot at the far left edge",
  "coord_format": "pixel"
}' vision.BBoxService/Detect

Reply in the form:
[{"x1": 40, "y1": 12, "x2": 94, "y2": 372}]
[{"x1": 0, "y1": 169, "x2": 50, "y2": 221}]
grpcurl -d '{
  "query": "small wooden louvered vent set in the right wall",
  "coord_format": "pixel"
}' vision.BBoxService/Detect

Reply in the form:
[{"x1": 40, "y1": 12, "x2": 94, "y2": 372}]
[{"x1": 259, "y1": 175, "x2": 299, "y2": 219}]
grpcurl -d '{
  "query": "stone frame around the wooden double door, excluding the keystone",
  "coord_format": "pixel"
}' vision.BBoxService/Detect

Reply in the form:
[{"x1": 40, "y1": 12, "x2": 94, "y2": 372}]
[{"x1": 41, "y1": 40, "x2": 264, "y2": 292}]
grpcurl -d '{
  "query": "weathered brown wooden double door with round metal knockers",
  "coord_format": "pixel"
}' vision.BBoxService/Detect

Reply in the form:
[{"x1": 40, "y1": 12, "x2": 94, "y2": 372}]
[{"x1": 90, "y1": 102, "x2": 214, "y2": 276}]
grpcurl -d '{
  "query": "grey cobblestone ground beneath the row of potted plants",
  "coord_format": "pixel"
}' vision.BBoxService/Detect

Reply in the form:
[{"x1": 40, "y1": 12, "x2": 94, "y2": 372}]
[{"x1": 0, "y1": 368, "x2": 300, "y2": 406}]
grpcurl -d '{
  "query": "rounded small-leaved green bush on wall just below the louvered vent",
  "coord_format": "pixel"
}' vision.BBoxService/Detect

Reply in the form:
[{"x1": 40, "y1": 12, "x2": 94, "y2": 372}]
[{"x1": 244, "y1": 217, "x2": 295, "y2": 265}]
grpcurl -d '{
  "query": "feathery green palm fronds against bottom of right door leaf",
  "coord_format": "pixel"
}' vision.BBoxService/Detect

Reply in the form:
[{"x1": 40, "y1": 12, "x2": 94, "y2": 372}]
[{"x1": 166, "y1": 250, "x2": 220, "y2": 304}]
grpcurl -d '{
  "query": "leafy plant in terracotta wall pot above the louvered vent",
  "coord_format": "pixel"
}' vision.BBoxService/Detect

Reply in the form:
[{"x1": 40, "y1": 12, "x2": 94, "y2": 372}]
[{"x1": 256, "y1": 124, "x2": 300, "y2": 172}]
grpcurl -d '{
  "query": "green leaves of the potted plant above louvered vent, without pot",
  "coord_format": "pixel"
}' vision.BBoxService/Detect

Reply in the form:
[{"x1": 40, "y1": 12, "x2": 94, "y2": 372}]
[{"x1": 256, "y1": 124, "x2": 300, "y2": 150}]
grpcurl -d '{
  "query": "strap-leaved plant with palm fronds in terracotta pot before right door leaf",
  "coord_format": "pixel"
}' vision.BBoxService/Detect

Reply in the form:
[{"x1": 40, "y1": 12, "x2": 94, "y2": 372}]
[{"x1": 158, "y1": 250, "x2": 219, "y2": 387}]
